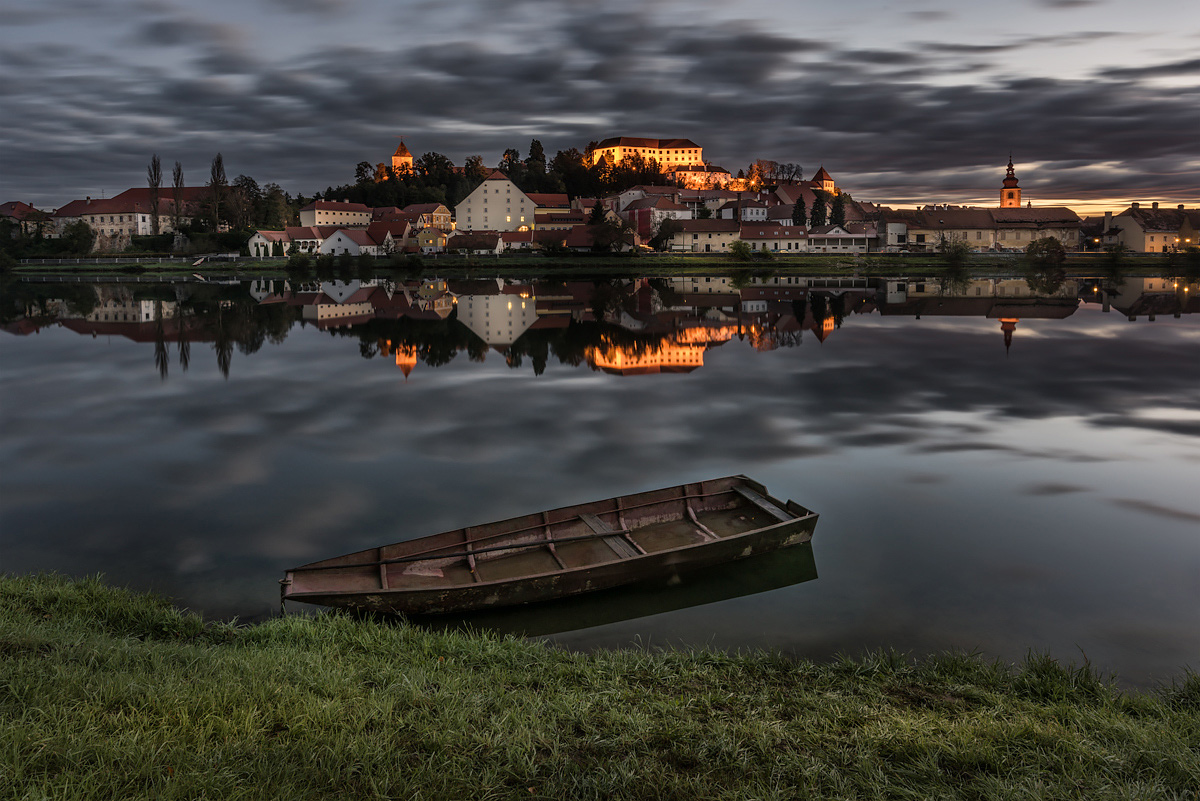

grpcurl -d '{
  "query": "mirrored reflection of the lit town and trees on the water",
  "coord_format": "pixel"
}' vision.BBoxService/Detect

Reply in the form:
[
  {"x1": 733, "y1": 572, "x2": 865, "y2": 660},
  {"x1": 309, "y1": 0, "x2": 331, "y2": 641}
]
[{"x1": 0, "y1": 271, "x2": 1200, "y2": 379}]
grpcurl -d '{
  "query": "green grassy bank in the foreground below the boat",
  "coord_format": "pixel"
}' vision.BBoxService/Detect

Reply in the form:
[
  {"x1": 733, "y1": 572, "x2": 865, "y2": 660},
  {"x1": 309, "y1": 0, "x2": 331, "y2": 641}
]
[{"x1": 0, "y1": 577, "x2": 1200, "y2": 799}]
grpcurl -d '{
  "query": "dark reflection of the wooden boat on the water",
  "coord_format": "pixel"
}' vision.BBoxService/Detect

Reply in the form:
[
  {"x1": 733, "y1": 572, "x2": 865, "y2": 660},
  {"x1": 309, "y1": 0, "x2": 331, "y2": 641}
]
[{"x1": 408, "y1": 543, "x2": 817, "y2": 636}]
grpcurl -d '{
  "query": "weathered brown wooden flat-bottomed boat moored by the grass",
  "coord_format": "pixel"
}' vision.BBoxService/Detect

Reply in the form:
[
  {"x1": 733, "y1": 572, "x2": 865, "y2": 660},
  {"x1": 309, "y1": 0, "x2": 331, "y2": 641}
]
[{"x1": 281, "y1": 476, "x2": 817, "y2": 615}]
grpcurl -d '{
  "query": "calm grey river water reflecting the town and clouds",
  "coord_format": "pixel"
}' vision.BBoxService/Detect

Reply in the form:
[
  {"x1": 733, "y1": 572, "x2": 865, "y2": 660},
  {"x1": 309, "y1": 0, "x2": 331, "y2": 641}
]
[{"x1": 0, "y1": 277, "x2": 1200, "y2": 686}]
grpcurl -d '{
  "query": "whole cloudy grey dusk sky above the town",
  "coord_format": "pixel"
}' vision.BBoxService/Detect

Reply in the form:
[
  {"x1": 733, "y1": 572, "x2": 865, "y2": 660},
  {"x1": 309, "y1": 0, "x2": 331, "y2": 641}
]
[{"x1": 0, "y1": 0, "x2": 1200, "y2": 213}]
